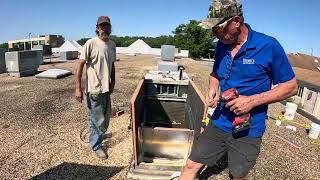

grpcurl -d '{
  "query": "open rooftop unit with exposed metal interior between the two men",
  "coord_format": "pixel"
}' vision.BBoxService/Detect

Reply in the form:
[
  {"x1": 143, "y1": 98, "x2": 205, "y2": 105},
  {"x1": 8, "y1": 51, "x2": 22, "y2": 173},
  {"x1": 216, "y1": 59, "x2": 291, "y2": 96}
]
[{"x1": 127, "y1": 71, "x2": 206, "y2": 180}]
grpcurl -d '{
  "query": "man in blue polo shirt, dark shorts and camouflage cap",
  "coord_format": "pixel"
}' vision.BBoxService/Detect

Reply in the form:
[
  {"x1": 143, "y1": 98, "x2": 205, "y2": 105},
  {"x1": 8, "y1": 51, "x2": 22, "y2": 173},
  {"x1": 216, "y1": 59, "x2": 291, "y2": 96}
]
[{"x1": 179, "y1": 0, "x2": 297, "y2": 180}]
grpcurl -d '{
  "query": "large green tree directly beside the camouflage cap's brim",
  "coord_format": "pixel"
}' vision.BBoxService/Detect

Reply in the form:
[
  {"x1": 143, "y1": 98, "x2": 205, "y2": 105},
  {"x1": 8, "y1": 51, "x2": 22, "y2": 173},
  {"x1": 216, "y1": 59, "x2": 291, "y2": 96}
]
[{"x1": 173, "y1": 20, "x2": 215, "y2": 59}]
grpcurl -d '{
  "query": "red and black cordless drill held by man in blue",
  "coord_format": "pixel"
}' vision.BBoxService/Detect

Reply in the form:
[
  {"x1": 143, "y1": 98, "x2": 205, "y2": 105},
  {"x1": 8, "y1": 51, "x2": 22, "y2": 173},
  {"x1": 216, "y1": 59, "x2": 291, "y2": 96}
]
[{"x1": 220, "y1": 88, "x2": 250, "y2": 133}]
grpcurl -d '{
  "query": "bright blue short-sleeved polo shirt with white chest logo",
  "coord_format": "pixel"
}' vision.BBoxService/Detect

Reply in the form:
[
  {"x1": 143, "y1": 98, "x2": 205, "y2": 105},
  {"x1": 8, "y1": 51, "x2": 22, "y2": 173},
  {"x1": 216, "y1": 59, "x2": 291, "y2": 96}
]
[{"x1": 211, "y1": 24, "x2": 295, "y2": 137}]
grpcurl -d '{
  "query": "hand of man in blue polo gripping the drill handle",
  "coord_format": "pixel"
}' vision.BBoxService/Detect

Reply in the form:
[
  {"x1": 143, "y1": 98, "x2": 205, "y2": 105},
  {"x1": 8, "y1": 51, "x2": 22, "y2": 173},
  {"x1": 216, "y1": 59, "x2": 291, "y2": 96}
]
[{"x1": 226, "y1": 95, "x2": 255, "y2": 115}]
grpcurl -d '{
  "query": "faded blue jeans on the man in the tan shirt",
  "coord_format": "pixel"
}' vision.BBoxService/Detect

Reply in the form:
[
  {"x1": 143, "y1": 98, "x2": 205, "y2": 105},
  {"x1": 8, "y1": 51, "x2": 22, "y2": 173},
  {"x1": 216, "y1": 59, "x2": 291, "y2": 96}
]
[{"x1": 87, "y1": 92, "x2": 111, "y2": 151}]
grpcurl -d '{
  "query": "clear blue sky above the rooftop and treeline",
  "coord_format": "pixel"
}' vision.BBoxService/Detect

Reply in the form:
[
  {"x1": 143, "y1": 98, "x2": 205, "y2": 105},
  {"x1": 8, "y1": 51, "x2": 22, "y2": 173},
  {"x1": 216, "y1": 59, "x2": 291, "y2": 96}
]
[{"x1": 0, "y1": 0, "x2": 320, "y2": 56}]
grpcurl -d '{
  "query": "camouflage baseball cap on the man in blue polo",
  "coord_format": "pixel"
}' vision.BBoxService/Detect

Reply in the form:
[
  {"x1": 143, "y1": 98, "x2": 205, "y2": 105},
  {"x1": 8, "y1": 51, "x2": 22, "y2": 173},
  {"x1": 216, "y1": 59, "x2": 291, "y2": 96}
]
[{"x1": 199, "y1": 0, "x2": 242, "y2": 29}]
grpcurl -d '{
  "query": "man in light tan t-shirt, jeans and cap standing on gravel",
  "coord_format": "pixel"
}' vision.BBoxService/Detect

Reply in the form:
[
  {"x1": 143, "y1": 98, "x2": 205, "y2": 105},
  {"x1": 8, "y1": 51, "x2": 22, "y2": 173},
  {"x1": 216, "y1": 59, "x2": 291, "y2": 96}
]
[{"x1": 75, "y1": 16, "x2": 116, "y2": 159}]
